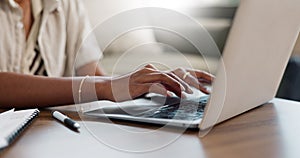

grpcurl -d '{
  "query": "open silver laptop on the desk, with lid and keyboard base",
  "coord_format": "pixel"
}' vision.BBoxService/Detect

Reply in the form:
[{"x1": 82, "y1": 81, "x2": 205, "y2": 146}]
[{"x1": 84, "y1": 0, "x2": 300, "y2": 130}]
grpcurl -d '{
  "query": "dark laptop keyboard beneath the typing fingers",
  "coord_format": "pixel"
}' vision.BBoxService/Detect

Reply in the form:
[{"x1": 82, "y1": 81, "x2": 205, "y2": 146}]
[{"x1": 143, "y1": 96, "x2": 209, "y2": 121}]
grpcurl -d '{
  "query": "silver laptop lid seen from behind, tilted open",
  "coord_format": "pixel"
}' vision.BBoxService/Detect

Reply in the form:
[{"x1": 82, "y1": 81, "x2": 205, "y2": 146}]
[{"x1": 199, "y1": 0, "x2": 300, "y2": 129}]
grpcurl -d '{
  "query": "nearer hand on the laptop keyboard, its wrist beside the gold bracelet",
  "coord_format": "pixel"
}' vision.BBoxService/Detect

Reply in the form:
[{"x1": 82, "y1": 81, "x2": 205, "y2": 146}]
[{"x1": 99, "y1": 65, "x2": 192, "y2": 101}]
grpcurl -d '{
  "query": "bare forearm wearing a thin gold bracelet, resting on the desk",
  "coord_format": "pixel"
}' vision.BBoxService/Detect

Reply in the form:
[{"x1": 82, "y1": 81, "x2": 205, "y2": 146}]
[{"x1": 0, "y1": 73, "x2": 109, "y2": 108}]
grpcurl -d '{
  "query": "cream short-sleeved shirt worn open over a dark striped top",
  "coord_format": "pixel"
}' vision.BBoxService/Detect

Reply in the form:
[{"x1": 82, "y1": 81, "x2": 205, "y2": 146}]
[{"x1": 0, "y1": 0, "x2": 102, "y2": 77}]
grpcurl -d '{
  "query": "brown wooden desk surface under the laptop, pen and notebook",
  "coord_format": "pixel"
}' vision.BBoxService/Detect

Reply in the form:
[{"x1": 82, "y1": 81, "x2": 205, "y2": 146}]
[{"x1": 0, "y1": 99, "x2": 300, "y2": 158}]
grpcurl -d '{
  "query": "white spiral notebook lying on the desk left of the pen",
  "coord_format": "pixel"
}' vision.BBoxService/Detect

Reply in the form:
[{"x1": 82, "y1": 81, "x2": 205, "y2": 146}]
[{"x1": 0, "y1": 109, "x2": 39, "y2": 150}]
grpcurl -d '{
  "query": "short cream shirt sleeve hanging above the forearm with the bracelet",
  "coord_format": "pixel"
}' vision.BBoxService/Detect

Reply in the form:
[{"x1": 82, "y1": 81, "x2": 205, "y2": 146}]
[{"x1": 65, "y1": 0, "x2": 102, "y2": 76}]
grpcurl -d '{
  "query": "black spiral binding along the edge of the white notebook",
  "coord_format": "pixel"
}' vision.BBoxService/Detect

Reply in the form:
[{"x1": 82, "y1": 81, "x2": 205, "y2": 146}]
[{"x1": 6, "y1": 110, "x2": 40, "y2": 144}]
